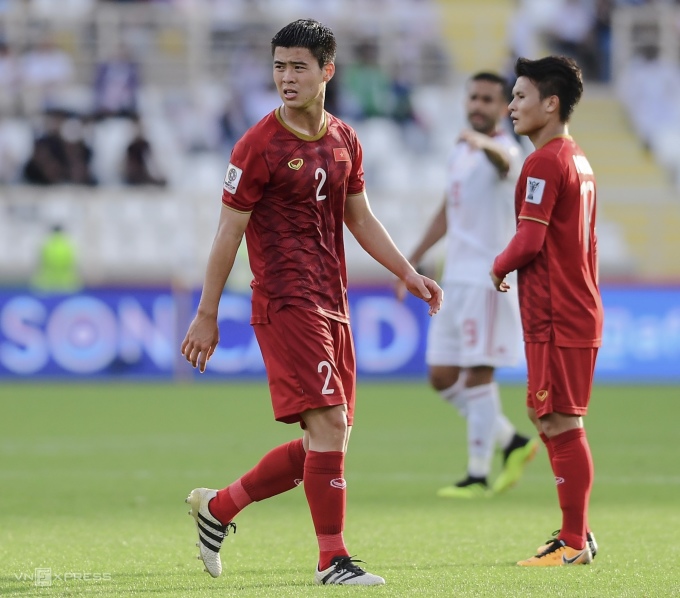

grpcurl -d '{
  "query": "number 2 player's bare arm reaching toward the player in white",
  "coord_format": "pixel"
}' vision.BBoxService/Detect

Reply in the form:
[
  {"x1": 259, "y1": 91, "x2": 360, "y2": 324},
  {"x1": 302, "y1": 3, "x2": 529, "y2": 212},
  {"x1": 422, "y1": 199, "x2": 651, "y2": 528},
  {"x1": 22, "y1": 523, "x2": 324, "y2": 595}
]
[{"x1": 345, "y1": 191, "x2": 443, "y2": 315}]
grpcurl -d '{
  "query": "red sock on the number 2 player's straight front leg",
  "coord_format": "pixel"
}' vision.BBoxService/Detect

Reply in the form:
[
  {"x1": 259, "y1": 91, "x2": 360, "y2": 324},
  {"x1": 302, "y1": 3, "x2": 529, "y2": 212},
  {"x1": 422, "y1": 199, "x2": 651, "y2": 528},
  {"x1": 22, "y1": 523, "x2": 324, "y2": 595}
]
[{"x1": 305, "y1": 451, "x2": 349, "y2": 571}]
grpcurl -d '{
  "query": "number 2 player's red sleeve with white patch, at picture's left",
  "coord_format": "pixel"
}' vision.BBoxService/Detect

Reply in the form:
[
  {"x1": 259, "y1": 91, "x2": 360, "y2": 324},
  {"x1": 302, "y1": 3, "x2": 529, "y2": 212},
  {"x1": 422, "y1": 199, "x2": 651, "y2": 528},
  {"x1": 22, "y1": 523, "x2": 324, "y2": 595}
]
[{"x1": 222, "y1": 139, "x2": 270, "y2": 213}]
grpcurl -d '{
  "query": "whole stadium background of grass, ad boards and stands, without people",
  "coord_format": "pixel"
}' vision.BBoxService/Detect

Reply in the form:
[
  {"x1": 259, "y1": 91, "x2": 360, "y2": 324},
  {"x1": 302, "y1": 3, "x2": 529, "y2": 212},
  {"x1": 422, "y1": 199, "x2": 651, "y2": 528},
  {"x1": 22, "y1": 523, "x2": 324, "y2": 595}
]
[{"x1": 0, "y1": 0, "x2": 680, "y2": 598}]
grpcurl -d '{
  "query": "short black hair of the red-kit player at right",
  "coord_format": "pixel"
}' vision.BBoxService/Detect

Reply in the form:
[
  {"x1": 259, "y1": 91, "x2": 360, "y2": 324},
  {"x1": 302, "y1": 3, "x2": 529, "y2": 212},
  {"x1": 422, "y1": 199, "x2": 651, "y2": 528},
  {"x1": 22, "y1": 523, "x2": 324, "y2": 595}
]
[{"x1": 515, "y1": 56, "x2": 583, "y2": 123}]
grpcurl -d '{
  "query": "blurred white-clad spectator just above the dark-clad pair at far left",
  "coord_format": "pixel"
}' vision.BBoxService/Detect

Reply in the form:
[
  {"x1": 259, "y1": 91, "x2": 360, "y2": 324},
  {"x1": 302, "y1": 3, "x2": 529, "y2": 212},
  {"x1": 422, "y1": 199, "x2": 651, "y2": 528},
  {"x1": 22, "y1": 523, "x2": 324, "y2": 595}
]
[{"x1": 21, "y1": 36, "x2": 74, "y2": 114}]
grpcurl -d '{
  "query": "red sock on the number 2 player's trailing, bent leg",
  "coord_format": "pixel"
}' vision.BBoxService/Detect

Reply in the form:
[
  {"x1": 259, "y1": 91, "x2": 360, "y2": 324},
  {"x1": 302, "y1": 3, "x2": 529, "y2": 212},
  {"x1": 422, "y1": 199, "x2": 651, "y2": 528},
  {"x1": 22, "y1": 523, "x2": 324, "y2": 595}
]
[{"x1": 209, "y1": 438, "x2": 306, "y2": 525}]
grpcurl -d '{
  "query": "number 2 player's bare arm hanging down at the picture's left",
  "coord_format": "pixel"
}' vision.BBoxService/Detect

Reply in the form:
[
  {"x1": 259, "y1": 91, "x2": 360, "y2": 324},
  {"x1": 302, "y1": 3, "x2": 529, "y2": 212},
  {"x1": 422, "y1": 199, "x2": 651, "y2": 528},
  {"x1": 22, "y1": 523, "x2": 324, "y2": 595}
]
[{"x1": 182, "y1": 206, "x2": 250, "y2": 373}]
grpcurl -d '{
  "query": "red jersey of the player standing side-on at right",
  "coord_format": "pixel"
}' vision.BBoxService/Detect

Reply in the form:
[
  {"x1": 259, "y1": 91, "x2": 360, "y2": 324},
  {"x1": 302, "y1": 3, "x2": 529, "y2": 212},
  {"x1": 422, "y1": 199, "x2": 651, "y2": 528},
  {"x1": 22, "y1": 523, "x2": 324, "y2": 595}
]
[{"x1": 515, "y1": 135, "x2": 603, "y2": 347}]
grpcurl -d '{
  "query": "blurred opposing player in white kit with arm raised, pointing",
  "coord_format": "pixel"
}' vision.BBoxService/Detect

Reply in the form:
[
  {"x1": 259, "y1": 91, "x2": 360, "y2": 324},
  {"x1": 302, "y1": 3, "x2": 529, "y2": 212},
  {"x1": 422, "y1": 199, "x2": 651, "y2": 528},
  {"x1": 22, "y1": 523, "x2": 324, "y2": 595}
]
[{"x1": 397, "y1": 73, "x2": 538, "y2": 498}]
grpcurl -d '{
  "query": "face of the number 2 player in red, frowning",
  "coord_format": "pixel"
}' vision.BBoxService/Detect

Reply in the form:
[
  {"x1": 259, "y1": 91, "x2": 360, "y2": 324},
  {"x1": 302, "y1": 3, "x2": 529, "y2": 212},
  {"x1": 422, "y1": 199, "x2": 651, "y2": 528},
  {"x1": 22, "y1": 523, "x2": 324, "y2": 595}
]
[{"x1": 274, "y1": 47, "x2": 335, "y2": 110}]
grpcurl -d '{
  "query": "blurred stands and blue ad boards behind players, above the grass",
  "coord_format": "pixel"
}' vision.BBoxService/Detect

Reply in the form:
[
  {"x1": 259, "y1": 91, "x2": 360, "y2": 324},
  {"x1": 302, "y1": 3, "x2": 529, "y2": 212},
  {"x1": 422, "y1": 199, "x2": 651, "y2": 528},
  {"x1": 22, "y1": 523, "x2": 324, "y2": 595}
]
[{"x1": 0, "y1": 0, "x2": 680, "y2": 382}]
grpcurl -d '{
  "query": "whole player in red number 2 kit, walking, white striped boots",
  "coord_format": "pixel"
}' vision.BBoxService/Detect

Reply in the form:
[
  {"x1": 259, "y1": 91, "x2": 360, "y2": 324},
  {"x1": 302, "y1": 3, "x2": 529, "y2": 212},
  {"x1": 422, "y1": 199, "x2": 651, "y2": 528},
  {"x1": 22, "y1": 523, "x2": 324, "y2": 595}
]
[{"x1": 182, "y1": 20, "x2": 443, "y2": 585}]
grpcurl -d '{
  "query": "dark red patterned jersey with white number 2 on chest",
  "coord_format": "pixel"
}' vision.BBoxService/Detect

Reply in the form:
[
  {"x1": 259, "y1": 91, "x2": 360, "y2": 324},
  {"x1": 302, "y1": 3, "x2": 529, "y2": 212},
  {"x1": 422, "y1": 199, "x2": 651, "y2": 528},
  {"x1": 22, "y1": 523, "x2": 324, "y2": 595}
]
[{"x1": 222, "y1": 108, "x2": 364, "y2": 324}]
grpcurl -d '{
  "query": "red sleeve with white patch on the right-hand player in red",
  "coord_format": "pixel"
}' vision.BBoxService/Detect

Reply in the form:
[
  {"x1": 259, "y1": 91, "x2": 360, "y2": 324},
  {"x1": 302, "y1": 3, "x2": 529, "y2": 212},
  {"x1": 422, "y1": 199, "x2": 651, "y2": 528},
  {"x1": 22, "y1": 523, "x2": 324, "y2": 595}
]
[{"x1": 518, "y1": 155, "x2": 563, "y2": 224}]
